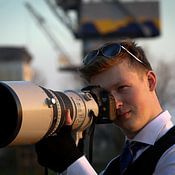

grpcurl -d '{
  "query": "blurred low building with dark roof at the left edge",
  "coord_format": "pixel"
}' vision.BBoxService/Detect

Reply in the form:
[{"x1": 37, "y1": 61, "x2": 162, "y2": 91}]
[{"x1": 0, "y1": 46, "x2": 32, "y2": 81}]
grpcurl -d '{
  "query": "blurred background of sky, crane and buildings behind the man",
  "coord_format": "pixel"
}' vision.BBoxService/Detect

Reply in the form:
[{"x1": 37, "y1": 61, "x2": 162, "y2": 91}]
[{"x1": 0, "y1": 0, "x2": 175, "y2": 175}]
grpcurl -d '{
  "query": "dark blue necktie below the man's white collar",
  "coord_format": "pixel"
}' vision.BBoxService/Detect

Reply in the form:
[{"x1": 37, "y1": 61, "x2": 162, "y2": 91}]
[{"x1": 120, "y1": 141, "x2": 147, "y2": 175}]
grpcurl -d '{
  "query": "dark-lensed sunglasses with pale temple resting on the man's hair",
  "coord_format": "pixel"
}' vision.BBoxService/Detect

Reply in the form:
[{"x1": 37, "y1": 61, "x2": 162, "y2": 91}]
[{"x1": 83, "y1": 43, "x2": 145, "y2": 65}]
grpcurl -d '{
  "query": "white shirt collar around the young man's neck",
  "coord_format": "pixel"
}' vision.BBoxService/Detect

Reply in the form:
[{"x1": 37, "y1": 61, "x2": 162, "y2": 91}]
[{"x1": 132, "y1": 111, "x2": 173, "y2": 145}]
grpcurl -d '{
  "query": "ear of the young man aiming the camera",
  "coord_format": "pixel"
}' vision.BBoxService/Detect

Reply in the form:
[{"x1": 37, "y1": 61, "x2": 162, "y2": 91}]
[{"x1": 147, "y1": 71, "x2": 157, "y2": 91}]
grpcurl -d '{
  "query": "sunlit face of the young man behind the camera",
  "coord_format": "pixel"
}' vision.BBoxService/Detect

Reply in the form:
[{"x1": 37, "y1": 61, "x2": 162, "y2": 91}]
[{"x1": 90, "y1": 62, "x2": 154, "y2": 137}]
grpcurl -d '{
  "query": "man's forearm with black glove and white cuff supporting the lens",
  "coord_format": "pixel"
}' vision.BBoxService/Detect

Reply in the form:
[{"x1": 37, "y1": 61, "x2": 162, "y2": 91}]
[{"x1": 35, "y1": 111, "x2": 96, "y2": 175}]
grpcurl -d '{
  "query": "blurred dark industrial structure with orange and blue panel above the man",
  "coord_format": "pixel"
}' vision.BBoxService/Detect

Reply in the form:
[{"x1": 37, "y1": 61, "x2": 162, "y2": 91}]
[{"x1": 45, "y1": 0, "x2": 161, "y2": 71}]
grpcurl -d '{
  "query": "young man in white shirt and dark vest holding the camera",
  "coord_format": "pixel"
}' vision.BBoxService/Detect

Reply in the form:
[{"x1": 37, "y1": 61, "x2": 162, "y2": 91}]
[{"x1": 36, "y1": 40, "x2": 175, "y2": 175}]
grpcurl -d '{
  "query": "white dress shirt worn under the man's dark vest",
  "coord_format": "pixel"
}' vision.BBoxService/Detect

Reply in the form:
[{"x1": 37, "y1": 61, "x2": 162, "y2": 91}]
[{"x1": 59, "y1": 111, "x2": 175, "y2": 175}]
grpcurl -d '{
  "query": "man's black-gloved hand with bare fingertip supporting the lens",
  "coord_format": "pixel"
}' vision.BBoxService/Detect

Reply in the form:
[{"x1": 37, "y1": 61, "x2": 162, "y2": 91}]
[{"x1": 35, "y1": 110, "x2": 83, "y2": 172}]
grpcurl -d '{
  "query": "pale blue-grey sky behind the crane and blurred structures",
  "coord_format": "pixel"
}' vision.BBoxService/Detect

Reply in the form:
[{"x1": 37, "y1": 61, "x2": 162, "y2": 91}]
[{"x1": 0, "y1": 0, "x2": 175, "y2": 90}]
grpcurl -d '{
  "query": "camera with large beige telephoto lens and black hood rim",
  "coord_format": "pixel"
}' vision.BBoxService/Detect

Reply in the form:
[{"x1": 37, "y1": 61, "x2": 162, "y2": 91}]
[{"x1": 0, "y1": 81, "x2": 116, "y2": 148}]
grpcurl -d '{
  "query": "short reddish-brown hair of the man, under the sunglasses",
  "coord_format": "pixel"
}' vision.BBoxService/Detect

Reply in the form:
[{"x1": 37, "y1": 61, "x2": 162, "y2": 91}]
[{"x1": 79, "y1": 39, "x2": 152, "y2": 81}]
